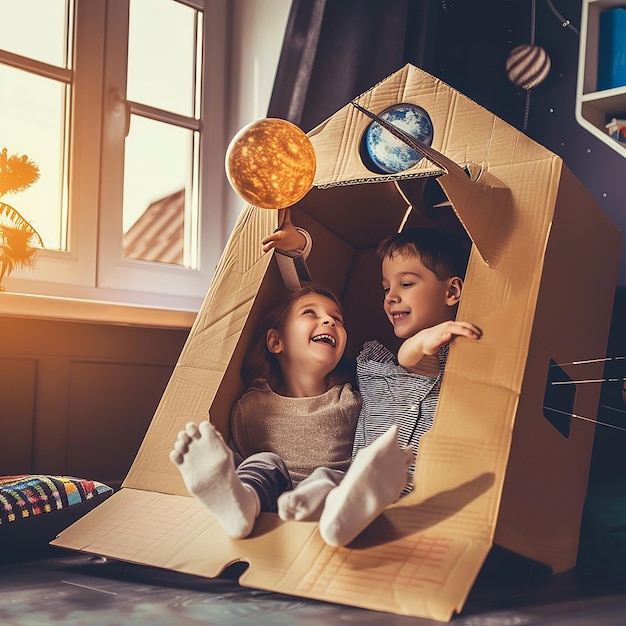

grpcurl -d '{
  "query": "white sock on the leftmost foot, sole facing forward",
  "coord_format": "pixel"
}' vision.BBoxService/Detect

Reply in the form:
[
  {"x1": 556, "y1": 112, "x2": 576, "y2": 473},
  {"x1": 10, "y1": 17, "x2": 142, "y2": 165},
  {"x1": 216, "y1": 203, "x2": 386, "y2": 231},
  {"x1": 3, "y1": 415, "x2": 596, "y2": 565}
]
[{"x1": 170, "y1": 421, "x2": 260, "y2": 539}]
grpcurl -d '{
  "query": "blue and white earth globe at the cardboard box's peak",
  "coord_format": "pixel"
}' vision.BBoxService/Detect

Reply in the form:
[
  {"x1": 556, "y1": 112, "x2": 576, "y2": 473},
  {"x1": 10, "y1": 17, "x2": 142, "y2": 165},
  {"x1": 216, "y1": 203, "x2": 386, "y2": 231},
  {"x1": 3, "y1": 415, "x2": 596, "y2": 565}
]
[{"x1": 361, "y1": 103, "x2": 433, "y2": 174}]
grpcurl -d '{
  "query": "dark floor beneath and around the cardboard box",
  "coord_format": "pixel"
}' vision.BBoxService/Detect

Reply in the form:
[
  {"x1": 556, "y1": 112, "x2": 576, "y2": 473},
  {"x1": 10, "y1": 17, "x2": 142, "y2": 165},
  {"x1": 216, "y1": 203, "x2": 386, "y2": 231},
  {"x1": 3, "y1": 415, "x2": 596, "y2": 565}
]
[{"x1": 0, "y1": 547, "x2": 626, "y2": 626}]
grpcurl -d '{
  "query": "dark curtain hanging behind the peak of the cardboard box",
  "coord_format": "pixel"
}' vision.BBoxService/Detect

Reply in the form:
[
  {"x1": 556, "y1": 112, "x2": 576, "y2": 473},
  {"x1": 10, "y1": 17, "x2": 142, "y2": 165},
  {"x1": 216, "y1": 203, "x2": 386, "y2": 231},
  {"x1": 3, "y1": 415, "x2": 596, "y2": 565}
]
[{"x1": 268, "y1": 0, "x2": 437, "y2": 132}]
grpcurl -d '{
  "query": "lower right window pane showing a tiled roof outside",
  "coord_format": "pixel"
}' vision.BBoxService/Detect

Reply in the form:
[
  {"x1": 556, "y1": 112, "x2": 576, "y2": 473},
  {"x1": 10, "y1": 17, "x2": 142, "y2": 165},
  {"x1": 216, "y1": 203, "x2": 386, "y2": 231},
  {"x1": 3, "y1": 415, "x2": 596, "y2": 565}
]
[{"x1": 124, "y1": 115, "x2": 197, "y2": 268}]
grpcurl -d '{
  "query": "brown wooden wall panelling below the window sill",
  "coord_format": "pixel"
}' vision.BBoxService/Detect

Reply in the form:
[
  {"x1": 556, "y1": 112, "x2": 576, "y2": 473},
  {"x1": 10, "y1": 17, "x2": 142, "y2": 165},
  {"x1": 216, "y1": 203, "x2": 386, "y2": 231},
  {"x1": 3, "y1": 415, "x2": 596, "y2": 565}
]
[{"x1": 0, "y1": 316, "x2": 189, "y2": 487}]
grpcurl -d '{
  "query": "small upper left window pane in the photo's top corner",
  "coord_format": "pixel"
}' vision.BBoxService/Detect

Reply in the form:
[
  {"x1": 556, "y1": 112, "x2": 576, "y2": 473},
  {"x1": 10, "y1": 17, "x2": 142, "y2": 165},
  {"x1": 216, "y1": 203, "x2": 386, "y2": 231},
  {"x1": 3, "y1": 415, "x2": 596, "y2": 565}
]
[{"x1": 0, "y1": 0, "x2": 69, "y2": 67}]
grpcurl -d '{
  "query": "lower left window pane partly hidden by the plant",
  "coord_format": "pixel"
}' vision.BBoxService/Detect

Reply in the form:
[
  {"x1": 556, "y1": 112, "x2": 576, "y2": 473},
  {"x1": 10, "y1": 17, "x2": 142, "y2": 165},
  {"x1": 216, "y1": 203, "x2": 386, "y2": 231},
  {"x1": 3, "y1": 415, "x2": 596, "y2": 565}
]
[{"x1": 0, "y1": 65, "x2": 67, "y2": 250}]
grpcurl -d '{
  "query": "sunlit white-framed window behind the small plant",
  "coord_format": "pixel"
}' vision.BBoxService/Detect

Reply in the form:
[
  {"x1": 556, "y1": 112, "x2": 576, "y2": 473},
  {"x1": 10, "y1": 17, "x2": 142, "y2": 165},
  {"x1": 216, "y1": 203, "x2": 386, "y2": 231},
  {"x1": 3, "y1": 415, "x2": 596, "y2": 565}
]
[{"x1": 0, "y1": 0, "x2": 226, "y2": 310}]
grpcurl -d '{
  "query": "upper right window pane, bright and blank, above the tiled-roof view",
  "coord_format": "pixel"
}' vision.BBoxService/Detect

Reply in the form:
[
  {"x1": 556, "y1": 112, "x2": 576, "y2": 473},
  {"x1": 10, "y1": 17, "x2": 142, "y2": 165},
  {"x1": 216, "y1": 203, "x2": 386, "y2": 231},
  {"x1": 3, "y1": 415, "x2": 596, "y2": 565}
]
[{"x1": 126, "y1": 0, "x2": 196, "y2": 117}]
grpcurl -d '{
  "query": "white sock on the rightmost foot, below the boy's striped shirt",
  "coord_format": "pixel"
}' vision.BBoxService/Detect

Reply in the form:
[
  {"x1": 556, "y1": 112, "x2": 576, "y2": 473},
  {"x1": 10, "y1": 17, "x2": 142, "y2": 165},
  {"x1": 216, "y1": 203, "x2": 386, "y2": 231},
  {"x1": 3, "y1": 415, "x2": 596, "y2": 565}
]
[{"x1": 320, "y1": 425, "x2": 415, "y2": 547}]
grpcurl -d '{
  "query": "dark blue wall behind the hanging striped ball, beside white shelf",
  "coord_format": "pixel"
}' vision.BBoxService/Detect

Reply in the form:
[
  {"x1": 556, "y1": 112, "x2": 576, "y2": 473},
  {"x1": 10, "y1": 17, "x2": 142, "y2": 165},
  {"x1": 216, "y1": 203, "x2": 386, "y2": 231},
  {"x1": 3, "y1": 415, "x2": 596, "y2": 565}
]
[{"x1": 422, "y1": 0, "x2": 626, "y2": 285}]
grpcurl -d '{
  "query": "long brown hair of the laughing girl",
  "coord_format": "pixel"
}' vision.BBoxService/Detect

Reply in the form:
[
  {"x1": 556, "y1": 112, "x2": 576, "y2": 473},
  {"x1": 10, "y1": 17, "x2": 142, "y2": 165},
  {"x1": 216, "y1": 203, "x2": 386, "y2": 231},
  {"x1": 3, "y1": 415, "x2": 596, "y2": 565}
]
[{"x1": 241, "y1": 285, "x2": 352, "y2": 391}]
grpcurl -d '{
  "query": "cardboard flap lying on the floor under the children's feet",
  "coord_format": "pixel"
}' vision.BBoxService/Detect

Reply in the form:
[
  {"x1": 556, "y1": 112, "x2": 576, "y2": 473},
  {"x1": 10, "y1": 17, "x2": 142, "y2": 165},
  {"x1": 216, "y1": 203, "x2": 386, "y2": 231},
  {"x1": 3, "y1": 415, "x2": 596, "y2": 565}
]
[{"x1": 51, "y1": 488, "x2": 491, "y2": 621}]
